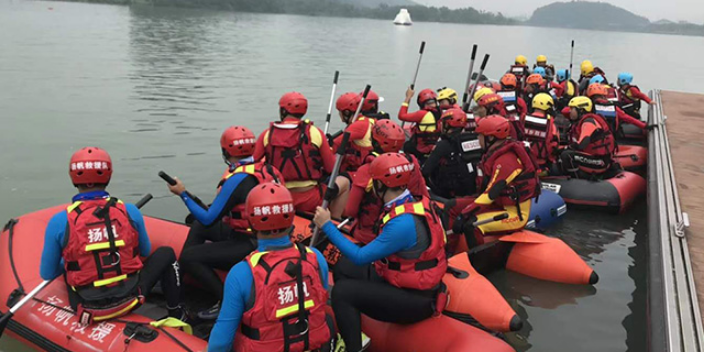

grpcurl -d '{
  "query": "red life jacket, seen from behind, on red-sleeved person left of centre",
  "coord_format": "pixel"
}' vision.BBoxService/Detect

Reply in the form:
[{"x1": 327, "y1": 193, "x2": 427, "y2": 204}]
[{"x1": 265, "y1": 120, "x2": 324, "y2": 181}]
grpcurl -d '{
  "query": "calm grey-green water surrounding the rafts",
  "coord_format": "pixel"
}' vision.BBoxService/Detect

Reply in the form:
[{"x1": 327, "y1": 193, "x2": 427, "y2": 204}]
[{"x1": 0, "y1": 0, "x2": 704, "y2": 351}]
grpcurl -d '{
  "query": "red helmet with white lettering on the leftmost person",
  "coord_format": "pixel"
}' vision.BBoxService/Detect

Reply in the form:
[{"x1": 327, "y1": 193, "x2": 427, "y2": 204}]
[{"x1": 68, "y1": 147, "x2": 112, "y2": 185}]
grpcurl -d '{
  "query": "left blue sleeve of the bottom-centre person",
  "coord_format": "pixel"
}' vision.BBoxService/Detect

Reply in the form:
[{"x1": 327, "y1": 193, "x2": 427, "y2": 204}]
[{"x1": 208, "y1": 262, "x2": 254, "y2": 352}]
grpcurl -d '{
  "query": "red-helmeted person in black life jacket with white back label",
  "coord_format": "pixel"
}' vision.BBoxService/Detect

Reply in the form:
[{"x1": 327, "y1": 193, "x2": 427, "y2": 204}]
[{"x1": 423, "y1": 107, "x2": 482, "y2": 198}]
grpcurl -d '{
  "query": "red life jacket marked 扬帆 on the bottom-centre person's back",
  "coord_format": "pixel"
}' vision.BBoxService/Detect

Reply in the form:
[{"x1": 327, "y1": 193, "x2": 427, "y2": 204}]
[{"x1": 234, "y1": 244, "x2": 331, "y2": 352}]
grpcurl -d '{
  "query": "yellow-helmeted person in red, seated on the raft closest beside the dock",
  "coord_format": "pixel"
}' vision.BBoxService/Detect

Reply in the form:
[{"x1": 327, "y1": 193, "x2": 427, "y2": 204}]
[{"x1": 560, "y1": 97, "x2": 621, "y2": 180}]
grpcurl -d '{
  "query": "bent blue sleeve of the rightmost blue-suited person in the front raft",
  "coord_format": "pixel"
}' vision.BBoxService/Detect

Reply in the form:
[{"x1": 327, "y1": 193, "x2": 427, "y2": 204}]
[{"x1": 323, "y1": 214, "x2": 417, "y2": 265}]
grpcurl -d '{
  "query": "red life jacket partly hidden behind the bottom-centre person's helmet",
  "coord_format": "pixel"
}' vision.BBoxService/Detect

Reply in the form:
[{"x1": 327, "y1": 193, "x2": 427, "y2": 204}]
[{"x1": 218, "y1": 162, "x2": 284, "y2": 235}]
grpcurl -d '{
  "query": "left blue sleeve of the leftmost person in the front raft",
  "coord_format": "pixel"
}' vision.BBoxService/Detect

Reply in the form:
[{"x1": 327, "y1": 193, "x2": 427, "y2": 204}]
[{"x1": 39, "y1": 211, "x2": 68, "y2": 280}]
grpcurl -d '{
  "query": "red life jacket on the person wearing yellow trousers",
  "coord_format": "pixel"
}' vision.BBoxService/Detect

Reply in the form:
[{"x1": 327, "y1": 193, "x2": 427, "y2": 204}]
[{"x1": 477, "y1": 141, "x2": 540, "y2": 210}]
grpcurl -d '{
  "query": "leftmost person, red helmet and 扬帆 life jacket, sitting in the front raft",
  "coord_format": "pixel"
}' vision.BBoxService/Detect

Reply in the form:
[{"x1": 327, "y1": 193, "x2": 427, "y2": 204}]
[{"x1": 39, "y1": 147, "x2": 187, "y2": 325}]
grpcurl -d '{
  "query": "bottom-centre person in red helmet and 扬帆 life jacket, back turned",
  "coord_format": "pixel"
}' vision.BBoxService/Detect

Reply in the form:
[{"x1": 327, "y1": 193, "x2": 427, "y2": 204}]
[{"x1": 208, "y1": 183, "x2": 333, "y2": 352}]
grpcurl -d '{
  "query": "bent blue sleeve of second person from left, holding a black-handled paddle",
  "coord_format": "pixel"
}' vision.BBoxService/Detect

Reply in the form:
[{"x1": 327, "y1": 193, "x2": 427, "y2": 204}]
[{"x1": 181, "y1": 173, "x2": 256, "y2": 226}]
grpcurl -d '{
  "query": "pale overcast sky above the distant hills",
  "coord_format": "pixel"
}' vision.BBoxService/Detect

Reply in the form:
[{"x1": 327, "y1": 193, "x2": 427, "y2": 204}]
[{"x1": 414, "y1": 0, "x2": 704, "y2": 24}]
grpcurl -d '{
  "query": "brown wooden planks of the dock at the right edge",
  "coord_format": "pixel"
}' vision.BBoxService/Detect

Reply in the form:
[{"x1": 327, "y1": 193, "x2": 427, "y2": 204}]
[{"x1": 662, "y1": 91, "x2": 704, "y2": 316}]
